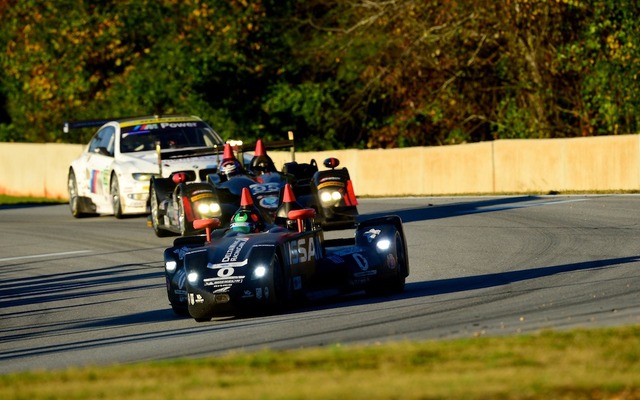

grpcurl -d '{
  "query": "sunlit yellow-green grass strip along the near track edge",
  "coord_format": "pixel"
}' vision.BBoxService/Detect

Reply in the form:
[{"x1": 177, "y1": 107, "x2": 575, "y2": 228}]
[{"x1": 0, "y1": 326, "x2": 640, "y2": 400}]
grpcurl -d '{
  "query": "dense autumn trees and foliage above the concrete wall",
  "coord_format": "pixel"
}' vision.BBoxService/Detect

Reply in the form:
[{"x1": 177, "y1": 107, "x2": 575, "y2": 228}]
[{"x1": 0, "y1": 0, "x2": 640, "y2": 149}]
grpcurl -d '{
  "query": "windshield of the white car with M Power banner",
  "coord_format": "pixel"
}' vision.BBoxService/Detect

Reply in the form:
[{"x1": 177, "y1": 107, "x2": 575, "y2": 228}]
[{"x1": 120, "y1": 122, "x2": 224, "y2": 153}]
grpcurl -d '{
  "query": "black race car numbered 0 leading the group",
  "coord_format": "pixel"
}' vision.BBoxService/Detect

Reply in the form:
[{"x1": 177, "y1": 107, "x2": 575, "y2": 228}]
[{"x1": 164, "y1": 184, "x2": 409, "y2": 322}]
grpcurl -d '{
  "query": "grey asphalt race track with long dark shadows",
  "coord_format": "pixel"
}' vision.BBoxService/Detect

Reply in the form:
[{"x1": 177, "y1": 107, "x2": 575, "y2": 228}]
[{"x1": 0, "y1": 195, "x2": 640, "y2": 374}]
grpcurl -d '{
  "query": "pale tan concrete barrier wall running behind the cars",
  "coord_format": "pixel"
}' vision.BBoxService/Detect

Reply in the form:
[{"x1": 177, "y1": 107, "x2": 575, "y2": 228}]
[{"x1": 0, "y1": 135, "x2": 640, "y2": 200}]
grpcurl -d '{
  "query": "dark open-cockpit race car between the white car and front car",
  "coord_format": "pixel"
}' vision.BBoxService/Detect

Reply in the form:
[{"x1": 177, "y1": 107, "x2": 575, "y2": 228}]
[{"x1": 149, "y1": 140, "x2": 358, "y2": 236}]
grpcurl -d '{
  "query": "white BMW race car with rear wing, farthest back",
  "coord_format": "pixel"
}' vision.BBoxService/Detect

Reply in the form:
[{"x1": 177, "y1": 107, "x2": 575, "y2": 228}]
[{"x1": 64, "y1": 115, "x2": 225, "y2": 218}]
